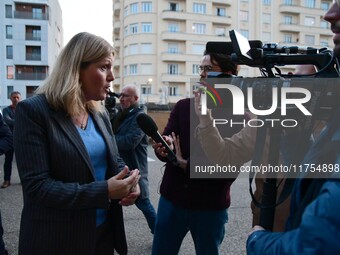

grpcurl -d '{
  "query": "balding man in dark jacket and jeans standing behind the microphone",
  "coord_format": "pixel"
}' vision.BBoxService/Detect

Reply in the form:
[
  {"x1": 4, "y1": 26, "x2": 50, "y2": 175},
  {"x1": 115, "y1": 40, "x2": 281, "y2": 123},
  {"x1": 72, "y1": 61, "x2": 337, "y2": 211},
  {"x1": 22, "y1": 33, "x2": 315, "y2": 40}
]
[{"x1": 113, "y1": 85, "x2": 156, "y2": 234}]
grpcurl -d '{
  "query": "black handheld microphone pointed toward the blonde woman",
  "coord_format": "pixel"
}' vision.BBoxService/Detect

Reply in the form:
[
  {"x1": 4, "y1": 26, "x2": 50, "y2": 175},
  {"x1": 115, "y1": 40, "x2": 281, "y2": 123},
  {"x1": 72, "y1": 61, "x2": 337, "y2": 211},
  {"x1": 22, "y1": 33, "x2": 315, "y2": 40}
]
[{"x1": 136, "y1": 113, "x2": 179, "y2": 166}]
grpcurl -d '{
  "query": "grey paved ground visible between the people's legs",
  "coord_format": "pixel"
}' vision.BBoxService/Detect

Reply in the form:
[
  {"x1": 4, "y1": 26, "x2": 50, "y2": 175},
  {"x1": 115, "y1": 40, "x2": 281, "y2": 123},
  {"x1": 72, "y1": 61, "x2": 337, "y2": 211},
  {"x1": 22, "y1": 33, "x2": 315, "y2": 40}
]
[{"x1": 0, "y1": 146, "x2": 251, "y2": 255}]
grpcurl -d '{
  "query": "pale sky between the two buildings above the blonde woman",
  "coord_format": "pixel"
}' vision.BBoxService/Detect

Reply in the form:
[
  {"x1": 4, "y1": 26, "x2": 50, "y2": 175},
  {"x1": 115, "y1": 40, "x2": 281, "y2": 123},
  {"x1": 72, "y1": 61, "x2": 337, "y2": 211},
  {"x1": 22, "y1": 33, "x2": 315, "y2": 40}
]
[{"x1": 58, "y1": 0, "x2": 113, "y2": 45}]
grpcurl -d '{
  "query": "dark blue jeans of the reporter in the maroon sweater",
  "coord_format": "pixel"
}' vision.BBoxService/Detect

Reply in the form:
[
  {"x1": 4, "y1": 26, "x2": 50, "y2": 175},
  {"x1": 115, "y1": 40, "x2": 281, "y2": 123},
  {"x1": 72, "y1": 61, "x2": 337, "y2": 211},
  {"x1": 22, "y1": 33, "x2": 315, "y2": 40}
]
[{"x1": 152, "y1": 196, "x2": 228, "y2": 255}]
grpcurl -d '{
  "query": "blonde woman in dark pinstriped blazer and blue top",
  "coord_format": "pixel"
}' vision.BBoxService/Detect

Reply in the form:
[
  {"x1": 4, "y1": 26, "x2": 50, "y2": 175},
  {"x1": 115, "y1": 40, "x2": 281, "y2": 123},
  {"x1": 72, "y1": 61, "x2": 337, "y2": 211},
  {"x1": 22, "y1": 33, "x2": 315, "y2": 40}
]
[{"x1": 14, "y1": 33, "x2": 140, "y2": 255}]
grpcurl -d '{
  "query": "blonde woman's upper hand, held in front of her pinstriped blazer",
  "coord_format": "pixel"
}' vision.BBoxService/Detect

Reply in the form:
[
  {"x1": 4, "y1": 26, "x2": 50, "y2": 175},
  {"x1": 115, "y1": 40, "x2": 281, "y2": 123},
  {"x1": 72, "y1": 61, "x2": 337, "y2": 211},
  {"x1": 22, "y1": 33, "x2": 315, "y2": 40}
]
[{"x1": 107, "y1": 166, "x2": 140, "y2": 199}]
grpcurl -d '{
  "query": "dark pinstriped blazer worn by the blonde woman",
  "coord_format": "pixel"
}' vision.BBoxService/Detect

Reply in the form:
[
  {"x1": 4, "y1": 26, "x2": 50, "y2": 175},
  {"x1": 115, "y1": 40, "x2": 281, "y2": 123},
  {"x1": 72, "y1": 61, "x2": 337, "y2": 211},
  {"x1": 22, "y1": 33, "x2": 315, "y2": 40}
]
[{"x1": 14, "y1": 95, "x2": 126, "y2": 255}]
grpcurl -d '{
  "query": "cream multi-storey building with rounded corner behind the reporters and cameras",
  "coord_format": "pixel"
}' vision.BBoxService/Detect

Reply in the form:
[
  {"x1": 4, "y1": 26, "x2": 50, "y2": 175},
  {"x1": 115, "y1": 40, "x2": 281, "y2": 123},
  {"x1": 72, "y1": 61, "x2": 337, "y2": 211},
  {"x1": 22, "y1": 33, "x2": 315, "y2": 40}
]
[{"x1": 113, "y1": 0, "x2": 333, "y2": 104}]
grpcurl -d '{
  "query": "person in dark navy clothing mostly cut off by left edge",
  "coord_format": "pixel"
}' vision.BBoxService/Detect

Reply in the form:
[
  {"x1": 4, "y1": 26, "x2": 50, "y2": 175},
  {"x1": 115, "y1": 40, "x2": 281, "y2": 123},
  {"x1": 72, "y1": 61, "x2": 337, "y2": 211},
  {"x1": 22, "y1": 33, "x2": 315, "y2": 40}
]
[{"x1": 0, "y1": 114, "x2": 13, "y2": 255}]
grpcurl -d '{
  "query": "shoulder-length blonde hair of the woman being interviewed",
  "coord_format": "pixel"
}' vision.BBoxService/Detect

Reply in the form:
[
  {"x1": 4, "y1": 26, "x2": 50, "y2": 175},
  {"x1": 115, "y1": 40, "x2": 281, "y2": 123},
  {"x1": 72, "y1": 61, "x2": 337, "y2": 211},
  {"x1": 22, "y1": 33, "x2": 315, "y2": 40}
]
[{"x1": 36, "y1": 32, "x2": 113, "y2": 116}]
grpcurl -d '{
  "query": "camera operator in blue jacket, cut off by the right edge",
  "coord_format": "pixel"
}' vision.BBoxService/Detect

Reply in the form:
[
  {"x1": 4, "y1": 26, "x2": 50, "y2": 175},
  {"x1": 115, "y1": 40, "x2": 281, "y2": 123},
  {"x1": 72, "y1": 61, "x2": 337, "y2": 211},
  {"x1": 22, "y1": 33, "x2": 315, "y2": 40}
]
[{"x1": 247, "y1": 0, "x2": 340, "y2": 255}]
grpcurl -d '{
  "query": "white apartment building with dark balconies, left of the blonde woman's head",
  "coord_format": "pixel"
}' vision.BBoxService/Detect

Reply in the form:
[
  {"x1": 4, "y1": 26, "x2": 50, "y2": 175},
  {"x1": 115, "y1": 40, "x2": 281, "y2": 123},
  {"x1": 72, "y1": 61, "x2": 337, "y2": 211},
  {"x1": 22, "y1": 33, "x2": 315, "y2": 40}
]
[{"x1": 0, "y1": 0, "x2": 63, "y2": 106}]
